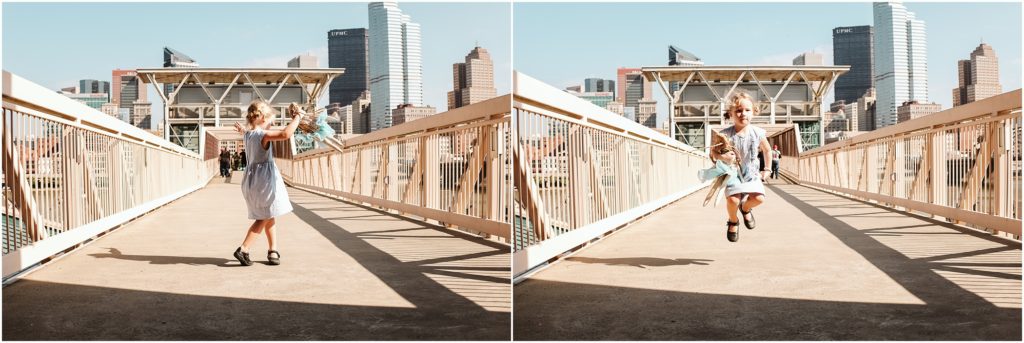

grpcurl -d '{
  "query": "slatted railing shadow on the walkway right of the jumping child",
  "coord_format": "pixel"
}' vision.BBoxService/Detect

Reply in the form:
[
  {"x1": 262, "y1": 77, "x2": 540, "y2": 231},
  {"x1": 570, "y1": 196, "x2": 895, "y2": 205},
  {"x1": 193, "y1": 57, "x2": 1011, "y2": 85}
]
[{"x1": 769, "y1": 186, "x2": 1021, "y2": 311}]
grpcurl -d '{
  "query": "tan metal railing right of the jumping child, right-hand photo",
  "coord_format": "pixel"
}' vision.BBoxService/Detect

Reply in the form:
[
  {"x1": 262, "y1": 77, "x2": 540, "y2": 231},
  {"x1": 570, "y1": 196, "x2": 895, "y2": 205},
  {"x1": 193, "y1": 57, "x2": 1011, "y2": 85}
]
[{"x1": 776, "y1": 89, "x2": 1022, "y2": 239}]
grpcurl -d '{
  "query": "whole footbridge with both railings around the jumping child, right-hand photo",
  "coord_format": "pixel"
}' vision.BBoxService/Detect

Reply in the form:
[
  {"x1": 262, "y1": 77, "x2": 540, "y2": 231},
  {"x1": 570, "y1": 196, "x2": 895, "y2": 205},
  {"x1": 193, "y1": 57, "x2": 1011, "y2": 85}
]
[{"x1": 513, "y1": 74, "x2": 1021, "y2": 340}]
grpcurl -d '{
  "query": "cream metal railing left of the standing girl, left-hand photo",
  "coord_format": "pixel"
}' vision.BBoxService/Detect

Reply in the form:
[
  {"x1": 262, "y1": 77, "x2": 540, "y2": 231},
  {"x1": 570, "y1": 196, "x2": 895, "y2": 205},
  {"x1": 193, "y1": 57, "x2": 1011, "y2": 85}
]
[{"x1": 0, "y1": 71, "x2": 212, "y2": 278}]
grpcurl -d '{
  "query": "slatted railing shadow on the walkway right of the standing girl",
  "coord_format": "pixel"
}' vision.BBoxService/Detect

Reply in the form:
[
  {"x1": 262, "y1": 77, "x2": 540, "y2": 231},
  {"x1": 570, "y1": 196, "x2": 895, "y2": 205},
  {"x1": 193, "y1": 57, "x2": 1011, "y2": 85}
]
[{"x1": 292, "y1": 188, "x2": 511, "y2": 323}]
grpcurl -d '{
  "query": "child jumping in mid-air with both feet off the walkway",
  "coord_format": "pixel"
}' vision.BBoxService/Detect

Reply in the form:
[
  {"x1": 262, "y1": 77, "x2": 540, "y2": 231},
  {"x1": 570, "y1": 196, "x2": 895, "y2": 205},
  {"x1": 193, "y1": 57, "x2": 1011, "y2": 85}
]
[{"x1": 712, "y1": 91, "x2": 770, "y2": 242}]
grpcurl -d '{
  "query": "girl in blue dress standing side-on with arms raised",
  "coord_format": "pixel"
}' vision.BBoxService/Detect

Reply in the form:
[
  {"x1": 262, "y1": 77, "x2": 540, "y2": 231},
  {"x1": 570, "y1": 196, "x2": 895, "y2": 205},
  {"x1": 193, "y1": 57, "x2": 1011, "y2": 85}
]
[{"x1": 234, "y1": 100, "x2": 304, "y2": 265}]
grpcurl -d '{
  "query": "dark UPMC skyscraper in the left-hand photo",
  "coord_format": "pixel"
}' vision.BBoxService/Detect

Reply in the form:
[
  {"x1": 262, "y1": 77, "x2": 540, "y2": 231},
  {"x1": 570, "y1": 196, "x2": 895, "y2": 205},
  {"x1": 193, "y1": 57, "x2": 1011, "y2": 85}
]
[{"x1": 327, "y1": 28, "x2": 370, "y2": 105}]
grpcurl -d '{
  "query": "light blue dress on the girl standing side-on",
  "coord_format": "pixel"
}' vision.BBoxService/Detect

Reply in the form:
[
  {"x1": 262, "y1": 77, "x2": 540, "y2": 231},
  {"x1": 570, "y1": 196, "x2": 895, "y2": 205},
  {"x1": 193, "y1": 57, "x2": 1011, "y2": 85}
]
[{"x1": 242, "y1": 128, "x2": 292, "y2": 220}]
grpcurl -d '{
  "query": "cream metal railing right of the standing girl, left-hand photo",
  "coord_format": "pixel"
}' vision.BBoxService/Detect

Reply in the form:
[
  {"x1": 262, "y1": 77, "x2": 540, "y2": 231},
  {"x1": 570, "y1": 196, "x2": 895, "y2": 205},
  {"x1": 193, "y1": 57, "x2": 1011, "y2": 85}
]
[{"x1": 278, "y1": 95, "x2": 512, "y2": 241}]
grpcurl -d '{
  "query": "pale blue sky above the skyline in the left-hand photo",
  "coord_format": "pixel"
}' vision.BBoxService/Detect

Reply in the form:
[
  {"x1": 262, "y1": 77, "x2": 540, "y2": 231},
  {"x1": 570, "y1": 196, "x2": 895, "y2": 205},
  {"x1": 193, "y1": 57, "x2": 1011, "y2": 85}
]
[{"x1": 2, "y1": 2, "x2": 512, "y2": 124}]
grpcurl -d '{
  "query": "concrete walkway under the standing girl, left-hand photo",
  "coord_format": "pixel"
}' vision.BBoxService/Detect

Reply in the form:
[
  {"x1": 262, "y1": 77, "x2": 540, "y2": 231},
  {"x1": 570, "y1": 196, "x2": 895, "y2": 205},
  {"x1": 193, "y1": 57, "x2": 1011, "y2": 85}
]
[{"x1": 3, "y1": 174, "x2": 511, "y2": 340}]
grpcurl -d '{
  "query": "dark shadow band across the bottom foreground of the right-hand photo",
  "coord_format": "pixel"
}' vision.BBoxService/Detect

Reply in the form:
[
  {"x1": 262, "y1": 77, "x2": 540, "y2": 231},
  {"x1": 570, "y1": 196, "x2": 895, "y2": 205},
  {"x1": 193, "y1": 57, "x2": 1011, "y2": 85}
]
[{"x1": 513, "y1": 280, "x2": 1021, "y2": 341}]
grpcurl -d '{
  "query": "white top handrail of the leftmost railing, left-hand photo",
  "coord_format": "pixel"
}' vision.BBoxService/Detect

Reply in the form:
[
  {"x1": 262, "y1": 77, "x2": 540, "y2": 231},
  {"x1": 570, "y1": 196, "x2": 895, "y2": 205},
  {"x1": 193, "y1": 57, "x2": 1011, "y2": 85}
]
[{"x1": 3, "y1": 70, "x2": 200, "y2": 159}]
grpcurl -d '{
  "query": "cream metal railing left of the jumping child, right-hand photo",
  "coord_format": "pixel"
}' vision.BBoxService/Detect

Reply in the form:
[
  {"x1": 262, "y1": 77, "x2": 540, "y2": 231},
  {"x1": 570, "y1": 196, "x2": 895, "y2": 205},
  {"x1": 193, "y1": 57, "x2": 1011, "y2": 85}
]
[{"x1": 512, "y1": 73, "x2": 711, "y2": 276}]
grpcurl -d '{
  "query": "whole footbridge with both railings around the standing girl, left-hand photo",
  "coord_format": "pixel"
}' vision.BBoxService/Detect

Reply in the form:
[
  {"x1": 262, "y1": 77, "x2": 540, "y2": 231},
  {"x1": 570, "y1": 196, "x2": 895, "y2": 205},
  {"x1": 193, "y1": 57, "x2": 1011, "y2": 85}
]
[{"x1": 2, "y1": 72, "x2": 511, "y2": 340}]
